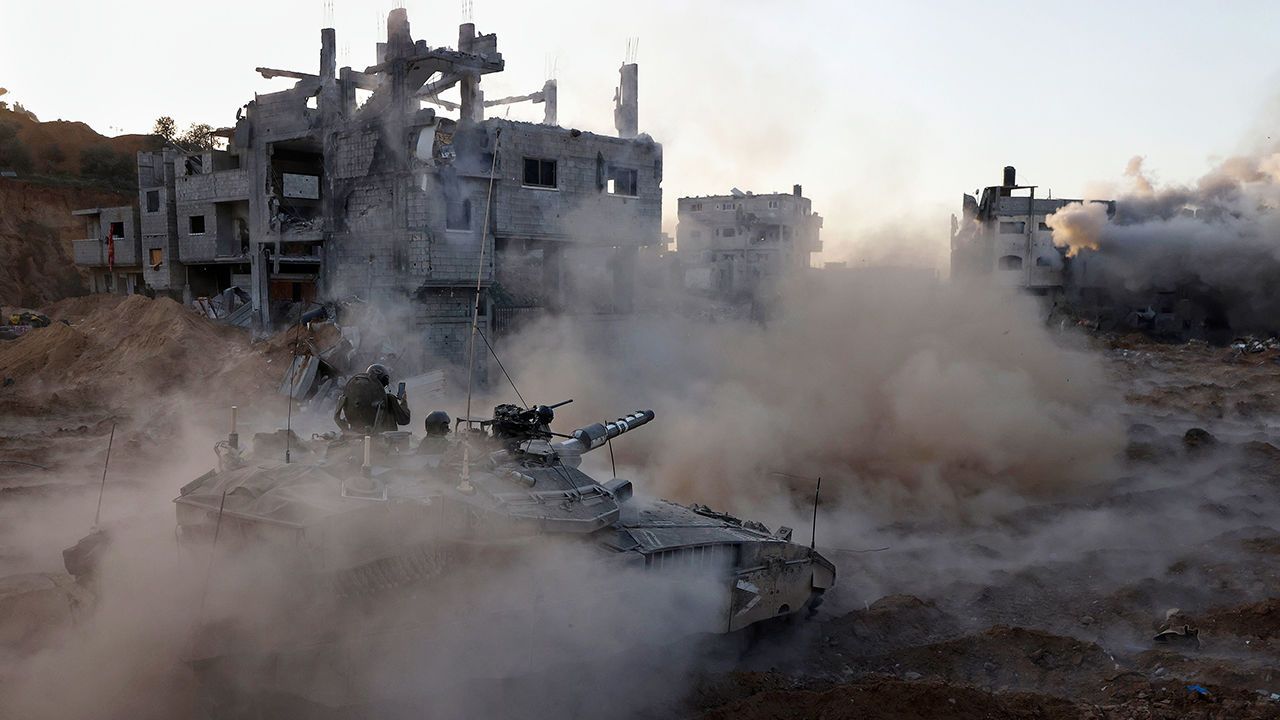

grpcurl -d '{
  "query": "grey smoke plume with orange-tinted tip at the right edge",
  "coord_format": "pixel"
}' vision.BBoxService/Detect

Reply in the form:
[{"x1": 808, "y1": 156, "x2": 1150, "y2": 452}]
[{"x1": 1047, "y1": 151, "x2": 1280, "y2": 332}]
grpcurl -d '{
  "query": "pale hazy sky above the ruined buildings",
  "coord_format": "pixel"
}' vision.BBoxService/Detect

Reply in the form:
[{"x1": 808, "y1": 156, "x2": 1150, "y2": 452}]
[{"x1": 0, "y1": 0, "x2": 1280, "y2": 263}]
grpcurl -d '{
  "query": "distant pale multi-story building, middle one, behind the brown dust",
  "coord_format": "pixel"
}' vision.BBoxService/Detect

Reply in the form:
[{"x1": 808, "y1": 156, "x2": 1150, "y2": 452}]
[{"x1": 676, "y1": 184, "x2": 822, "y2": 299}]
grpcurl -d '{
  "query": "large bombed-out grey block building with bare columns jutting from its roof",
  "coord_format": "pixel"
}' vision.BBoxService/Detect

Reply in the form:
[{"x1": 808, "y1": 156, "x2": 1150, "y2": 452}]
[{"x1": 76, "y1": 9, "x2": 662, "y2": 360}]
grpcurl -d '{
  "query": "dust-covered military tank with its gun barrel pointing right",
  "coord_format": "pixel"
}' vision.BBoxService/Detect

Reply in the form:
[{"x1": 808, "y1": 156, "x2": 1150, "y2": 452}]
[{"x1": 174, "y1": 405, "x2": 836, "y2": 697}]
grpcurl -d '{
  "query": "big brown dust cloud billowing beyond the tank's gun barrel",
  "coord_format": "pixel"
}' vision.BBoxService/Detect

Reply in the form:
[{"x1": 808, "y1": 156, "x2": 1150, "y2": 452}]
[{"x1": 486, "y1": 270, "x2": 1124, "y2": 519}]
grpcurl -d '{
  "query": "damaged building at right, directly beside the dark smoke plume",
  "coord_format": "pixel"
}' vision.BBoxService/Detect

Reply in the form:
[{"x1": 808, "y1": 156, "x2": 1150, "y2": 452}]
[{"x1": 951, "y1": 167, "x2": 1115, "y2": 295}]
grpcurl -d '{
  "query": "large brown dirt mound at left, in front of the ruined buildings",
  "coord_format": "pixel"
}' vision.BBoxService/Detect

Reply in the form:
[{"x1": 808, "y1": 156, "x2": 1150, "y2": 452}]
[{"x1": 0, "y1": 295, "x2": 284, "y2": 405}]
